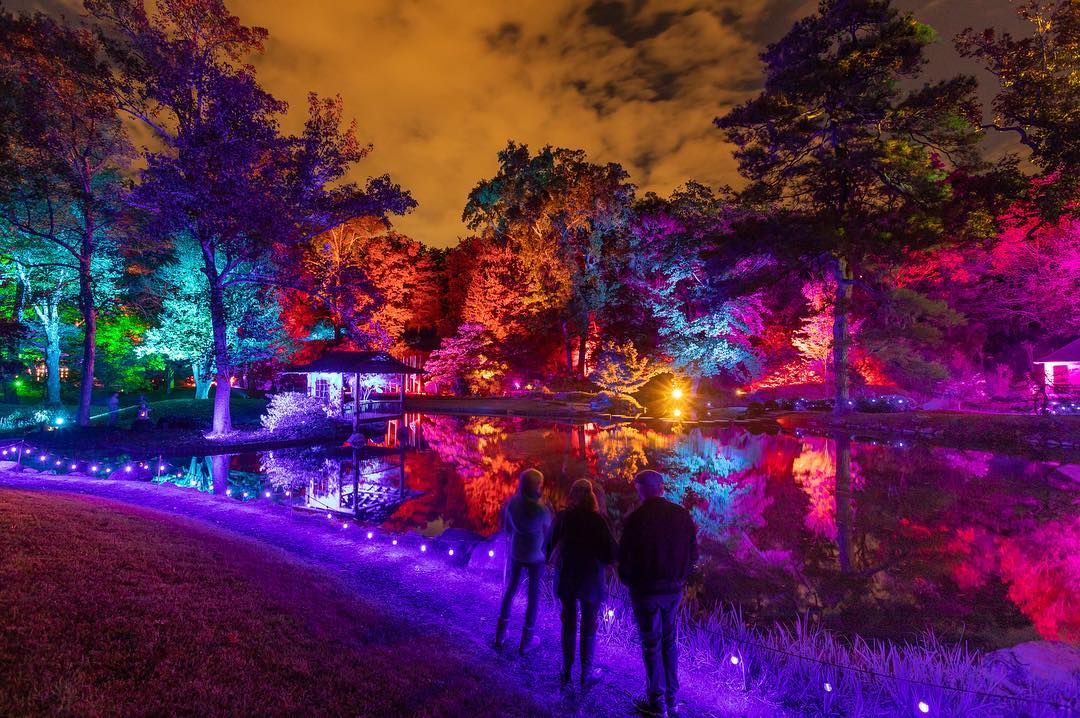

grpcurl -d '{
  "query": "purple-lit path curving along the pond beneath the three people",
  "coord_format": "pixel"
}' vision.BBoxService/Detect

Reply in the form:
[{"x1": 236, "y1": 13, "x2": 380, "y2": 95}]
[{"x1": 0, "y1": 472, "x2": 780, "y2": 718}]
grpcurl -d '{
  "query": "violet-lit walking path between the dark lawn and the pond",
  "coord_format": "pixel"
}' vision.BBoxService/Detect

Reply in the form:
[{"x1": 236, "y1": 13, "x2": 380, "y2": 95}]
[{"x1": 0, "y1": 472, "x2": 782, "y2": 718}]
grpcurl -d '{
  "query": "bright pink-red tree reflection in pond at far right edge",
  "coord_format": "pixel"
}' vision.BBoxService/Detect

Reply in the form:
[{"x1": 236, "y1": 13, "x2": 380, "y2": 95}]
[{"x1": 1000, "y1": 515, "x2": 1080, "y2": 644}]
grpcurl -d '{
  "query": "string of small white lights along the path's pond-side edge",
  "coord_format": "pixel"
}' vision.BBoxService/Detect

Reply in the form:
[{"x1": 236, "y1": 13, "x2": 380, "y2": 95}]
[{"x1": 6, "y1": 439, "x2": 1076, "y2": 715}]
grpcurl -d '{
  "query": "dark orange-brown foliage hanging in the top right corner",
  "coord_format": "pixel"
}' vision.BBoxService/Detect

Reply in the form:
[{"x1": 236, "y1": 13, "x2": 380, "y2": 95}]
[{"x1": 956, "y1": 0, "x2": 1080, "y2": 224}]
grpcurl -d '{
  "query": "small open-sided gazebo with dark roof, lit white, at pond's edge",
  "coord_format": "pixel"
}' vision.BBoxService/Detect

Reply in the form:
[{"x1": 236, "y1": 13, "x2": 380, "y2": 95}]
[{"x1": 283, "y1": 351, "x2": 423, "y2": 430}]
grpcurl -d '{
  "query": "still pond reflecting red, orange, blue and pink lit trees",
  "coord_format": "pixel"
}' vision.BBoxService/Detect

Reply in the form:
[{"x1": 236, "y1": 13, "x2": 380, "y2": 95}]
[{"x1": 14, "y1": 415, "x2": 1080, "y2": 649}]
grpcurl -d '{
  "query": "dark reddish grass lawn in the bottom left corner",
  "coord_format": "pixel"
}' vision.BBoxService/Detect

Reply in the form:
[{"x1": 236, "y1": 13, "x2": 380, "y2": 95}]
[{"x1": 0, "y1": 489, "x2": 541, "y2": 716}]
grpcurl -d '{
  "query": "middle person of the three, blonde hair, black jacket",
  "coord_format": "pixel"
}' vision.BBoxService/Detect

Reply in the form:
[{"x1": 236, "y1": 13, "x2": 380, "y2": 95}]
[{"x1": 545, "y1": 478, "x2": 618, "y2": 687}]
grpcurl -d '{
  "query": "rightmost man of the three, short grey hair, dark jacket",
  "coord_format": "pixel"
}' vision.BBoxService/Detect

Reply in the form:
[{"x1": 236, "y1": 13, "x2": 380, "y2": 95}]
[{"x1": 619, "y1": 471, "x2": 698, "y2": 716}]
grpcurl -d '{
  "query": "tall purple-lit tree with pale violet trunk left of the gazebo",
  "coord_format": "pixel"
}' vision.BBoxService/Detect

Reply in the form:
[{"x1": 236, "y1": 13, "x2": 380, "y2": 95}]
[{"x1": 86, "y1": 0, "x2": 415, "y2": 434}]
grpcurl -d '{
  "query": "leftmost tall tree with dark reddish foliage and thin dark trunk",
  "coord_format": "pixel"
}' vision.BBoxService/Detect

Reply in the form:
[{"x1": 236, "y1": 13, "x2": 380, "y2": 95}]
[{"x1": 0, "y1": 12, "x2": 133, "y2": 425}]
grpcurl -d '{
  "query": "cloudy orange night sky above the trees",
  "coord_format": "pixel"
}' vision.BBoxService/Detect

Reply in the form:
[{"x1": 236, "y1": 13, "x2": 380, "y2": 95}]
[{"x1": 21, "y1": 0, "x2": 1015, "y2": 246}]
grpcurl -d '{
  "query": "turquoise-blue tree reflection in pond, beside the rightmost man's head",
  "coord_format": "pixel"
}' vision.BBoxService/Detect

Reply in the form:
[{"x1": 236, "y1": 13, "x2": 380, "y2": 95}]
[{"x1": 662, "y1": 429, "x2": 769, "y2": 541}]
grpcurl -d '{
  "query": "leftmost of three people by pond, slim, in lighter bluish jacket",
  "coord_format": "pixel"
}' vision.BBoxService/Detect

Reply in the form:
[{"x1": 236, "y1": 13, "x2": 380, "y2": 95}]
[{"x1": 495, "y1": 469, "x2": 551, "y2": 654}]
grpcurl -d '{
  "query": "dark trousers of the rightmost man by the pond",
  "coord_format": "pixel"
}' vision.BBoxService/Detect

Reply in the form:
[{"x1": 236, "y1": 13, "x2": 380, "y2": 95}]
[{"x1": 631, "y1": 594, "x2": 683, "y2": 702}]
